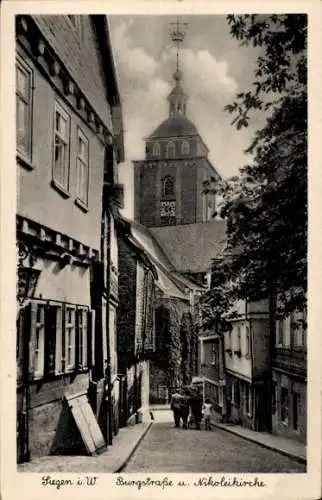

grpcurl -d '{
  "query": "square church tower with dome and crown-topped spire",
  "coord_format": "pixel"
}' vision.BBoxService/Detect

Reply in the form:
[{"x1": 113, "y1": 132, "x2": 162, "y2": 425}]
[{"x1": 134, "y1": 22, "x2": 219, "y2": 227}]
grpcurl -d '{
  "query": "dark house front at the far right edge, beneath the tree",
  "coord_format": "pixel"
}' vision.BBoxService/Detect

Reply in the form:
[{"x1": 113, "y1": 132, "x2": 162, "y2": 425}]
[{"x1": 272, "y1": 312, "x2": 307, "y2": 443}]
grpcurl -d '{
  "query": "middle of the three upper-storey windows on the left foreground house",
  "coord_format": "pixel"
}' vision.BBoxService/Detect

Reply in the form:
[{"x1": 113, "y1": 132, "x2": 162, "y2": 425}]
[{"x1": 53, "y1": 102, "x2": 70, "y2": 191}]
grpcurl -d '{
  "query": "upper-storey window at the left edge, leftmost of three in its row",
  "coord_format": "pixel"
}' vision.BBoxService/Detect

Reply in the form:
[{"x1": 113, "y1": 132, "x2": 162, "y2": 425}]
[{"x1": 16, "y1": 60, "x2": 32, "y2": 160}]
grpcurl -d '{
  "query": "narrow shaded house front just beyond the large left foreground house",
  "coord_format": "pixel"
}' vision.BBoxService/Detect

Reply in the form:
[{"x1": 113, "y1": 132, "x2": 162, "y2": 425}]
[{"x1": 117, "y1": 220, "x2": 156, "y2": 426}]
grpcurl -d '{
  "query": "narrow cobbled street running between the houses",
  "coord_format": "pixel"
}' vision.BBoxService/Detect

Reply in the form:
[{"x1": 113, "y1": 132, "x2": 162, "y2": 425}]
[{"x1": 124, "y1": 411, "x2": 305, "y2": 473}]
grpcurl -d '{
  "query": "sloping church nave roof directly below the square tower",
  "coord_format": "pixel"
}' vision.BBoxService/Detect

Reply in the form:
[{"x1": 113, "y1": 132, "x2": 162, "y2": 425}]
[{"x1": 149, "y1": 220, "x2": 226, "y2": 273}]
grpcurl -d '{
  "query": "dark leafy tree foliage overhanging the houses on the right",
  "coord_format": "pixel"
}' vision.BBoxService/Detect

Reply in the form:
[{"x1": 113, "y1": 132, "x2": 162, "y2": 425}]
[{"x1": 203, "y1": 14, "x2": 307, "y2": 324}]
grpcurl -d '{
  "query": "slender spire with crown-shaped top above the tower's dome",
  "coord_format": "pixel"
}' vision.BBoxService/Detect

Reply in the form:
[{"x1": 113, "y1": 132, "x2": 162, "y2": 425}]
[{"x1": 168, "y1": 18, "x2": 188, "y2": 116}]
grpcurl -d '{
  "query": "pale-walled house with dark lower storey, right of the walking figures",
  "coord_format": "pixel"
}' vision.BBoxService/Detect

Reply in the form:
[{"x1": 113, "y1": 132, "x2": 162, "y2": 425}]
[{"x1": 224, "y1": 300, "x2": 270, "y2": 431}]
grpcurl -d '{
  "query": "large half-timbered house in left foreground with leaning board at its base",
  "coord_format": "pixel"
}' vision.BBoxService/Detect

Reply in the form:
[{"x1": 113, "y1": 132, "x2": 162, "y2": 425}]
[{"x1": 16, "y1": 16, "x2": 123, "y2": 461}]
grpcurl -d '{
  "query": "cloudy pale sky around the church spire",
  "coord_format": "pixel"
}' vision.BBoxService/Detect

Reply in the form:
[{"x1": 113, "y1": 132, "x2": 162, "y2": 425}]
[{"x1": 109, "y1": 15, "x2": 257, "y2": 217}]
